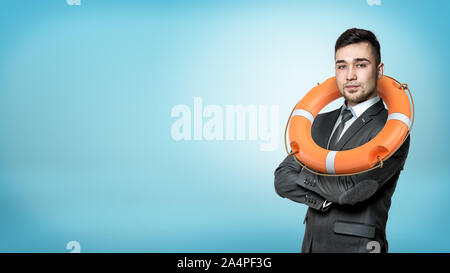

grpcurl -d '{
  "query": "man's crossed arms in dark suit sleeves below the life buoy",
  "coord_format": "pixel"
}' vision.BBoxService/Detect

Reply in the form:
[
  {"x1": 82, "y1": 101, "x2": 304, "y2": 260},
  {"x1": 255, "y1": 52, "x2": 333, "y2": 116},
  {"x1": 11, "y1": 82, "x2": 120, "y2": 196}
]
[{"x1": 275, "y1": 136, "x2": 410, "y2": 210}]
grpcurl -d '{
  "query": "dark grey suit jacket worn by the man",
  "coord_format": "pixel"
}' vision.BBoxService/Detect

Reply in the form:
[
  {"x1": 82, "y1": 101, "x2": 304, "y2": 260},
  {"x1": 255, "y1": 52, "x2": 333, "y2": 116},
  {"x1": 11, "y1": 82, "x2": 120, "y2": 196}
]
[{"x1": 275, "y1": 100, "x2": 409, "y2": 252}]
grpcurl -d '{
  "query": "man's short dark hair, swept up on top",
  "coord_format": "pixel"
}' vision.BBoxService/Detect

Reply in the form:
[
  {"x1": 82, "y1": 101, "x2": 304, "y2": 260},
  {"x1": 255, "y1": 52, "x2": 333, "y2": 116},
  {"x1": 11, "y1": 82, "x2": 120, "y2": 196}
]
[{"x1": 334, "y1": 28, "x2": 381, "y2": 65}]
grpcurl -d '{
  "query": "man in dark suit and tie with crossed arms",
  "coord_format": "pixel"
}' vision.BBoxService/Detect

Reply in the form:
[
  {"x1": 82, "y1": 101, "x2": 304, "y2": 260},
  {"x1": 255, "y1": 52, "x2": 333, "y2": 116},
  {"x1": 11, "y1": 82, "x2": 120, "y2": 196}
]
[{"x1": 275, "y1": 28, "x2": 409, "y2": 252}]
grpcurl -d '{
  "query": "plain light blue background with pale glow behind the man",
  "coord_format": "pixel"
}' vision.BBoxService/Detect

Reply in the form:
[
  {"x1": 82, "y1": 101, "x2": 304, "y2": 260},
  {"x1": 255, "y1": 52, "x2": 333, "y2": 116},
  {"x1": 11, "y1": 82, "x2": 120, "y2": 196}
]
[{"x1": 0, "y1": 0, "x2": 450, "y2": 252}]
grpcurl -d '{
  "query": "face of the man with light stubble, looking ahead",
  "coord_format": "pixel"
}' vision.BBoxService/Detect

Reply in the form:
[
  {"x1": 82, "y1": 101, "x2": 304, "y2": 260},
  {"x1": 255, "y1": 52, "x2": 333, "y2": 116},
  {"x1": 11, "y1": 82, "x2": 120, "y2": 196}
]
[{"x1": 335, "y1": 42, "x2": 384, "y2": 107}]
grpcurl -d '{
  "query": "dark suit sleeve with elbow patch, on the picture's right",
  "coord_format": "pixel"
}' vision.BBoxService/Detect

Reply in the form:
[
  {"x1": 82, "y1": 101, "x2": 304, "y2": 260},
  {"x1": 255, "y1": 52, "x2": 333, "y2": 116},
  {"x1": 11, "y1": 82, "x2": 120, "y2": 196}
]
[{"x1": 296, "y1": 136, "x2": 410, "y2": 205}]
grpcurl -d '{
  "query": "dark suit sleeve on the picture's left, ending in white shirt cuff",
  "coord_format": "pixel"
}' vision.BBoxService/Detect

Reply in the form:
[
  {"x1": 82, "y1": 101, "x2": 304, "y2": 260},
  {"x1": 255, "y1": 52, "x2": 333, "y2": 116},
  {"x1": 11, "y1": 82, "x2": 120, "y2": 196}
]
[{"x1": 275, "y1": 151, "x2": 330, "y2": 211}]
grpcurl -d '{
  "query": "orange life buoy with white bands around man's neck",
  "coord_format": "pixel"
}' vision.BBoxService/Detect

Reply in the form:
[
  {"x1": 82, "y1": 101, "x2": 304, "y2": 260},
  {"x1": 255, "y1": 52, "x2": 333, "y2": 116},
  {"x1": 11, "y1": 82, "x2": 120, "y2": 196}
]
[{"x1": 289, "y1": 76, "x2": 411, "y2": 174}]
